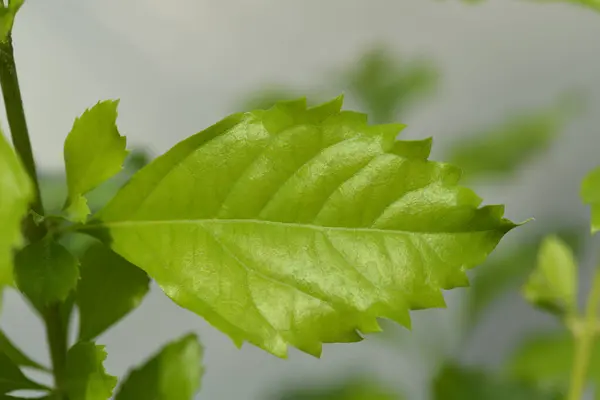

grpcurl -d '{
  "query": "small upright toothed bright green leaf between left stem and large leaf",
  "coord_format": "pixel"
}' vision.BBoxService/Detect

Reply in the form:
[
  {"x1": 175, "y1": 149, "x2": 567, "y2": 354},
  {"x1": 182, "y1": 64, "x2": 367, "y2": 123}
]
[{"x1": 64, "y1": 100, "x2": 127, "y2": 222}]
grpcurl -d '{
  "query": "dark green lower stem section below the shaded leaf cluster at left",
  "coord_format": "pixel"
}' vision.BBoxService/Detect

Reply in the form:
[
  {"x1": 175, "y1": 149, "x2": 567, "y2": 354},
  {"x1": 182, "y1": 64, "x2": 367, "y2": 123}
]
[{"x1": 44, "y1": 304, "x2": 67, "y2": 400}]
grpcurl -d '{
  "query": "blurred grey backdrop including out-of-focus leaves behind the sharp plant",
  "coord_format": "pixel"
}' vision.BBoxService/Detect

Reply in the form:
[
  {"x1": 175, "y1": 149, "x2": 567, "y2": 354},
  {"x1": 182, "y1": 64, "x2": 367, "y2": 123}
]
[{"x1": 1, "y1": 0, "x2": 600, "y2": 400}]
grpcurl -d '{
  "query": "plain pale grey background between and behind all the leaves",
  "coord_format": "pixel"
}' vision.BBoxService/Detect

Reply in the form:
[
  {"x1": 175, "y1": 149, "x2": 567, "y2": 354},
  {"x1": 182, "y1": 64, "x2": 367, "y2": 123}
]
[{"x1": 2, "y1": 0, "x2": 600, "y2": 400}]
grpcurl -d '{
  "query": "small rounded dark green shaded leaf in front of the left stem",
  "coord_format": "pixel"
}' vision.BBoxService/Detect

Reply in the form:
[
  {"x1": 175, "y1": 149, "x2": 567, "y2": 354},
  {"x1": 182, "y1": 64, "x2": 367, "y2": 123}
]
[{"x1": 15, "y1": 237, "x2": 79, "y2": 310}]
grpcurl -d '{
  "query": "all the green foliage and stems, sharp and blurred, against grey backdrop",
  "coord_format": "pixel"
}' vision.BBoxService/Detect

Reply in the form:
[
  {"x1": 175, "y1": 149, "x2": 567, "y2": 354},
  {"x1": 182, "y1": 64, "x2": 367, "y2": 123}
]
[{"x1": 0, "y1": 0, "x2": 600, "y2": 400}]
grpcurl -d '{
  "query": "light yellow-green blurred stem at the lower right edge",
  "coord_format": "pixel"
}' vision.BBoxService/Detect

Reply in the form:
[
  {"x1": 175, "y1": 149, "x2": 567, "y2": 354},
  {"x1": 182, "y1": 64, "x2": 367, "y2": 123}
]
[{"x1": 568, "y1": 267, "x2": 600, "y2": 400}]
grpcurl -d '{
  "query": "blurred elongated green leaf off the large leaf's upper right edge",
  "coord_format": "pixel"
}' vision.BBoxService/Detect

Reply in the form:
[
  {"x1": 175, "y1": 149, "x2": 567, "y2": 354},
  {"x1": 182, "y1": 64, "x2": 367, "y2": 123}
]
[{"x1": 448, "y1": 95, "x2": 581, "y2": 179}]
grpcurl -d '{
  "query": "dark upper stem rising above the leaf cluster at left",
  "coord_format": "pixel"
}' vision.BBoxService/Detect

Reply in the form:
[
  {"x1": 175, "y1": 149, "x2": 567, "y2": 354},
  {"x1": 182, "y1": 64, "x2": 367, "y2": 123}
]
[{"x1": 0, "y1": 34, "x2": 46, "y2": 241}]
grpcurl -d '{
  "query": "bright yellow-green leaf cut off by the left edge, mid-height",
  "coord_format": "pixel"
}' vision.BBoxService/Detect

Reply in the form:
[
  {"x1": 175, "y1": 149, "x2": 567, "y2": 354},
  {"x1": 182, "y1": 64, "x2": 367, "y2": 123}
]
[{"x1": 0, "y1": 132, "x2": 33, "y2": 287}]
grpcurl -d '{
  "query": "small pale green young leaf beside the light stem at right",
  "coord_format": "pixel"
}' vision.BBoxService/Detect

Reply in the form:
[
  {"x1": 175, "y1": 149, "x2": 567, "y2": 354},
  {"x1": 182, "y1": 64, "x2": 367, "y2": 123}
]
[{"x1": 523, "y1": 236, "x2": 577, "y2": 315}]
